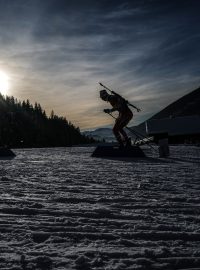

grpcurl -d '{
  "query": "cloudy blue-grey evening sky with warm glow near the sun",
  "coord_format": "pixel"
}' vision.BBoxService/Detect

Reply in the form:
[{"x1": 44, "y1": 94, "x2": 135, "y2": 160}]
[{"x1": 0, "y1": 0, "x2": 200, "y2": 130}]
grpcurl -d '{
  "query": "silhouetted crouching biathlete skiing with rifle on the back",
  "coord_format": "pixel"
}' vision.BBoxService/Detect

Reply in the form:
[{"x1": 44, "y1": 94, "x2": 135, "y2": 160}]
[{"x1": 100, "y1": 90, "x2": 140, "y2": 146}]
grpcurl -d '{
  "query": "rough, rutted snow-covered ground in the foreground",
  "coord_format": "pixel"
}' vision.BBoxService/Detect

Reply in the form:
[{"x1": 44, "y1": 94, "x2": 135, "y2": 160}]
[{"x1": 0, "y1": 146, "x2": 200, "y2": 270}]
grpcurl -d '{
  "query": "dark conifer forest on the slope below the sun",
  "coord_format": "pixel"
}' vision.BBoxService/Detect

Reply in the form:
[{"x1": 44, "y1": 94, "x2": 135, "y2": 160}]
[{"x1": 0, "y1": 94, "x2": 94, "y2": 148}]
